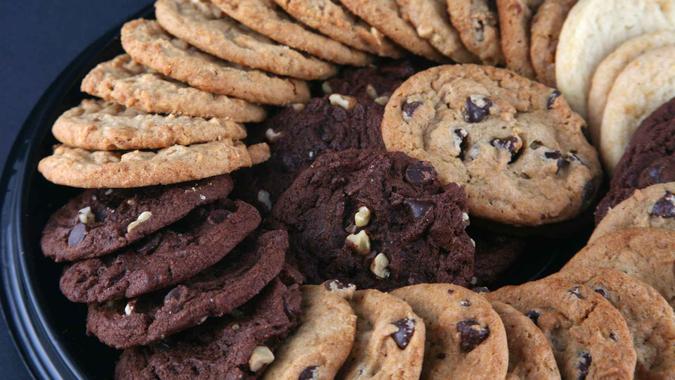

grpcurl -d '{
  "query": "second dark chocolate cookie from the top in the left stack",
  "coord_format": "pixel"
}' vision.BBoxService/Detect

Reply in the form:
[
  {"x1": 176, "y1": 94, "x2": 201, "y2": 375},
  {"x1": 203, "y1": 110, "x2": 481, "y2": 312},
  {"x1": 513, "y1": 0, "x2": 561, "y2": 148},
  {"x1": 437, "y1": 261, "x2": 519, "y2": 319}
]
[{"x1": 60, "y1": 201, "x2": 260, "y2": 303}]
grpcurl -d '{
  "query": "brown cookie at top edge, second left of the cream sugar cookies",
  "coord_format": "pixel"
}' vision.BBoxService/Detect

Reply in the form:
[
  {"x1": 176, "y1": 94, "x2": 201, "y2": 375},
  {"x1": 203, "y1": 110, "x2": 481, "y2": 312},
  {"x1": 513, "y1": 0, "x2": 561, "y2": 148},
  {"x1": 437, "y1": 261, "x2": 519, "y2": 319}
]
[{"x1": 497, "y1": 0, "x2": 543, "y2": 78}]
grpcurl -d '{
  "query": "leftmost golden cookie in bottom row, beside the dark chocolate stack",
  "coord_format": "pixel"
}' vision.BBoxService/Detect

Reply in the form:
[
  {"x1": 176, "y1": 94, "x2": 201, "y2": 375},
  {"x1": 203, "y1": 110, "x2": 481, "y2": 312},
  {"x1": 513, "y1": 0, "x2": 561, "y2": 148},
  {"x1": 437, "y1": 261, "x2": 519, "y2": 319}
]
[{"x1": 263, "y1": 285, "x2": 356, "y2": 380}]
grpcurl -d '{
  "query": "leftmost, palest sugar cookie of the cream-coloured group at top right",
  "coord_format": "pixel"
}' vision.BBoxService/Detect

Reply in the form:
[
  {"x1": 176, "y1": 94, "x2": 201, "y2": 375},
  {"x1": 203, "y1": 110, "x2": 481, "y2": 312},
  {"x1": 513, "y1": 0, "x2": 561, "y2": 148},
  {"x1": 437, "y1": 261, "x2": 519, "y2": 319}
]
[{"x1": 555, "y1": 0, "x2": 675, "y2": 117}]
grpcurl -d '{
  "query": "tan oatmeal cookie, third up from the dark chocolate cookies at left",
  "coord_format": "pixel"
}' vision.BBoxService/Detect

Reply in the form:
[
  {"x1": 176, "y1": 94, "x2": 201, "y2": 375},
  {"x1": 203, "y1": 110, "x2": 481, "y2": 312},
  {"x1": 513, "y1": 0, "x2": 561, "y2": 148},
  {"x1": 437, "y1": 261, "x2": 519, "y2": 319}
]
[{"x1": 81, "y1": 54, "x2": 266, "y2": 122}]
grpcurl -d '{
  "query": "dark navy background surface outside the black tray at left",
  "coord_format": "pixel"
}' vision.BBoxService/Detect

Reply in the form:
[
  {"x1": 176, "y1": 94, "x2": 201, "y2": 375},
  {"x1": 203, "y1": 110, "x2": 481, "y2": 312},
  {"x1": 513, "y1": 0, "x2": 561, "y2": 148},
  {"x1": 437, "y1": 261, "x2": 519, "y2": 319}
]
[{"x1": 0, "y1": 0, "x2": 151, "y2": 379}]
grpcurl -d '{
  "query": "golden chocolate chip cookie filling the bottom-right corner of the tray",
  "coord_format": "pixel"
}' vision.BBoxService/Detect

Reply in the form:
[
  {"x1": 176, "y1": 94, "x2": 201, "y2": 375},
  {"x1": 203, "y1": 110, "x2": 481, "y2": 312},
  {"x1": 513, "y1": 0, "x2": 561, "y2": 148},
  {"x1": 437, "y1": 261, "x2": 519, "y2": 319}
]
[{"x1": 558, "y1": 267, "x2": 675, "y2": 379}]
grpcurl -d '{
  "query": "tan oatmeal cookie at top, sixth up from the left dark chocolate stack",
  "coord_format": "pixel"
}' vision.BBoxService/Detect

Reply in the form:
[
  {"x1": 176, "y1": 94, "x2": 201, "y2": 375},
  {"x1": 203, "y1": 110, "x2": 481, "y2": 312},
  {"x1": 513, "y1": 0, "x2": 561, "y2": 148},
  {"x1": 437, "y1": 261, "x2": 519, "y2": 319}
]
[{"x1": 212, "y1": 0, "x2": 371, "y2": 66}]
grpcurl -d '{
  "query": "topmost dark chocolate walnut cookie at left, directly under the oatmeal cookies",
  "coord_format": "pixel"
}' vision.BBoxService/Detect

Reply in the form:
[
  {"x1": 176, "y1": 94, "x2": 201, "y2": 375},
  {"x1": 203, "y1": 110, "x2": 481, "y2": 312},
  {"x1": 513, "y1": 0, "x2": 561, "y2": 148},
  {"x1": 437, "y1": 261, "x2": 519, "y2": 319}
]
[{"x1": 40, "y1": 175, "x2": 233, "y2": 262}]
